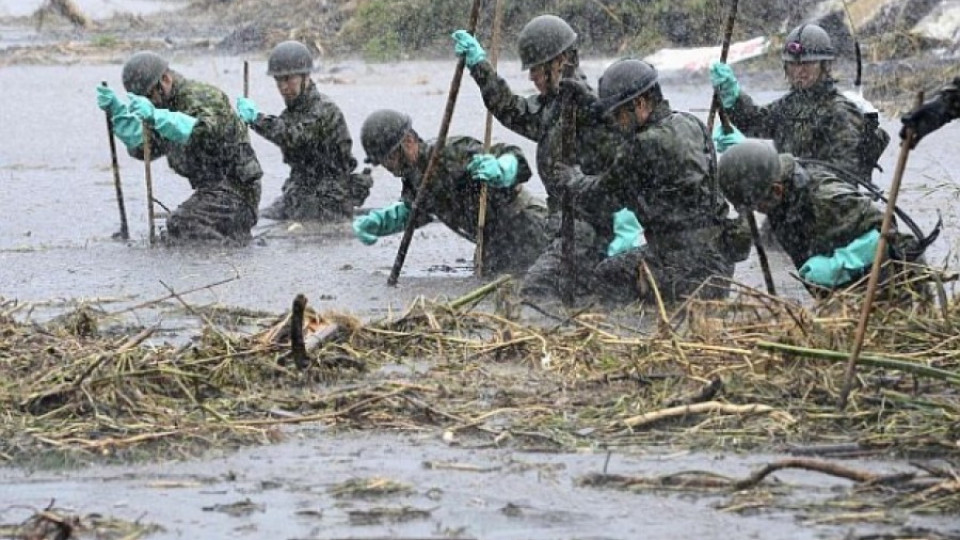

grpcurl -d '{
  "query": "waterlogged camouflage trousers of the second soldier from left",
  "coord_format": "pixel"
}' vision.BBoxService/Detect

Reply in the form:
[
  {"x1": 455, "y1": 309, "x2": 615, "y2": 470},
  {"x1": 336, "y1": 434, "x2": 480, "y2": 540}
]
[{"x1": 261, "y1": 169, "x2": 373, "y2": 221}]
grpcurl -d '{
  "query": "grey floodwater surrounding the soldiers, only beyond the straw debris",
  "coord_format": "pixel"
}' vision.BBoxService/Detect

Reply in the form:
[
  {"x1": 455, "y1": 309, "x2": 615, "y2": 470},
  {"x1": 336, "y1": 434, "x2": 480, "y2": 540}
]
[{"x1": 0, "y1": 56, "x2": 960, "y2": 323}]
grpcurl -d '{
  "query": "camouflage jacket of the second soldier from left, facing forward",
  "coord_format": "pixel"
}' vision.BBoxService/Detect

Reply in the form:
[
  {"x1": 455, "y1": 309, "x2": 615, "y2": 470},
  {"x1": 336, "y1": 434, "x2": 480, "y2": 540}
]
[{"x1": 250, "y1": 81, "x2": 357, "y2": 185}]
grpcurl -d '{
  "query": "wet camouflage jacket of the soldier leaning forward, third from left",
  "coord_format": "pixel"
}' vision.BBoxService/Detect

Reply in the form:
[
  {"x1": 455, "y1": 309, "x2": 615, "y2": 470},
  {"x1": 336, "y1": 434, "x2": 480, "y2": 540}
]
[{"x1": 401, "y1": 137, "x2": 531, "y2": 241}]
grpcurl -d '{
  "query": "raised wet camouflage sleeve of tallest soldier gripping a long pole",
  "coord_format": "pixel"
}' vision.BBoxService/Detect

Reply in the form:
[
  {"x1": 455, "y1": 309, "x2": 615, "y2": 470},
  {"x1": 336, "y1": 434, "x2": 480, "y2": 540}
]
[{"x1": 470, "y1": 61, "x2": 543, "y2": 141}]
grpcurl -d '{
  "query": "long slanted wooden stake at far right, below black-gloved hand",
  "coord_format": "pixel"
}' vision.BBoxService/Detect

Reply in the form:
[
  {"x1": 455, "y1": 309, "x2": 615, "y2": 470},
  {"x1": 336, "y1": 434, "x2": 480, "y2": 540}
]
[{"x1": 837, "y1": 92, "x2": 923, "y2": 410}]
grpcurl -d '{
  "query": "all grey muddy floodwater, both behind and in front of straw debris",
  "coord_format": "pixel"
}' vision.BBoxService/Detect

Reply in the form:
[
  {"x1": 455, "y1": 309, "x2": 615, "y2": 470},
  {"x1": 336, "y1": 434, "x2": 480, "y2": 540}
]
[{"x1": 0, "y1": 14, "x2": 960, "y2": 539}]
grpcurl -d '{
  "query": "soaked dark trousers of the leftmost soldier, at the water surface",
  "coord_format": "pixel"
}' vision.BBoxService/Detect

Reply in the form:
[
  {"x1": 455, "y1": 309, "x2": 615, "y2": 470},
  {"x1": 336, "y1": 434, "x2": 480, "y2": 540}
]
[{"x1": 164, "y1": 184, "x2": 259, "y2": 245}]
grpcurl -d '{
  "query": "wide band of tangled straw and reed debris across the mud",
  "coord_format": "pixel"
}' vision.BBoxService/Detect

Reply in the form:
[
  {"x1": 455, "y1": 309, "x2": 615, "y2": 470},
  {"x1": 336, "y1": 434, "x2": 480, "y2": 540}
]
[{"x1": 0, "y1": 281, "x2": 960, "y2": 463}]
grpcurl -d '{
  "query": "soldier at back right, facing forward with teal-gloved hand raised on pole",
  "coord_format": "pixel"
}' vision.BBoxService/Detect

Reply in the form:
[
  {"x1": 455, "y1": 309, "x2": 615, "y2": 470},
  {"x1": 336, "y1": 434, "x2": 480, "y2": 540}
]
[{"x1": 710, "y1": 24, "x2": 890, "y2": 181}]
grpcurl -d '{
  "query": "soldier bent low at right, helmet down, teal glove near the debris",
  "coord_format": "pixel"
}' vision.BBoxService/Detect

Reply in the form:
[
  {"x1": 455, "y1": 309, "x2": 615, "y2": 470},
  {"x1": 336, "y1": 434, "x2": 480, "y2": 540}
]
[{"x1": 719, "y1": 139, "x2": 925, "y2": 295}]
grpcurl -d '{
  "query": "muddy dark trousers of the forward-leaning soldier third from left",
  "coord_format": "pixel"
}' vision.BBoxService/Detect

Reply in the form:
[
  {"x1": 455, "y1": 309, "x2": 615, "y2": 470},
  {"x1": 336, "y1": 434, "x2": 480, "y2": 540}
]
[{"x1": 483, "y1": 194, "x2": 554, "y2": 274}]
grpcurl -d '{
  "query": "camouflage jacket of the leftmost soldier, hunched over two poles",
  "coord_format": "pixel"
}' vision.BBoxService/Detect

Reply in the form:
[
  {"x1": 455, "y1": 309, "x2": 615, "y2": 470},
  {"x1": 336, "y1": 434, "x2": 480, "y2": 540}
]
[{"x1": 130, "y1": 74, "x2": 263, "y2": 212}]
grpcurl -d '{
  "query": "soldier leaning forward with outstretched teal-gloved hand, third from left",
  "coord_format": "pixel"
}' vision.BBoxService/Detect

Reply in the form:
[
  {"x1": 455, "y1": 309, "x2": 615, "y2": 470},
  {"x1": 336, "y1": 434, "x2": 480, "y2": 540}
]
[{"x1": 353, "y1": 110, "x2": 552, "y2": 273}]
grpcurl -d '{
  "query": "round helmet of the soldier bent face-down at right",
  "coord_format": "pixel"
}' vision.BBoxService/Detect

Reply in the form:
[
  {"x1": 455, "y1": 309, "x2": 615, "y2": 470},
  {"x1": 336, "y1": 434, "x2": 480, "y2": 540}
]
[{"x1": 717, "y1": 139, "x2": 780, "y2": 208}]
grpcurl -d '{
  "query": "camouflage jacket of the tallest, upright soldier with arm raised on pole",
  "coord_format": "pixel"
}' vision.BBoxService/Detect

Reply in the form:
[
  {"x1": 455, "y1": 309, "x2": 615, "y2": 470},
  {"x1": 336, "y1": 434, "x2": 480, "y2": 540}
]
[{"x1": 470, "y1": 61, "x2": 623, "y2": 212}]
